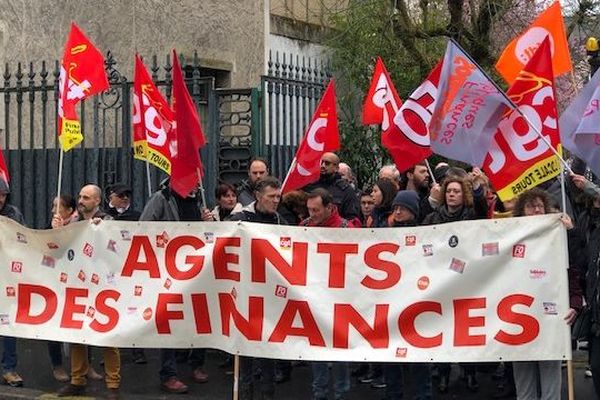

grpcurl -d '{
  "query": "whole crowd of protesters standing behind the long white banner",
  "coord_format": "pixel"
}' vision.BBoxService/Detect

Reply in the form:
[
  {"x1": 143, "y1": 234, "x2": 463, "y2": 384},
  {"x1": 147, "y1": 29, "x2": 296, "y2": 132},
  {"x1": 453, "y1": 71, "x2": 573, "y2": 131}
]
[{"x1": 0, "y1": 153, "x2": 600, "y2": 400}]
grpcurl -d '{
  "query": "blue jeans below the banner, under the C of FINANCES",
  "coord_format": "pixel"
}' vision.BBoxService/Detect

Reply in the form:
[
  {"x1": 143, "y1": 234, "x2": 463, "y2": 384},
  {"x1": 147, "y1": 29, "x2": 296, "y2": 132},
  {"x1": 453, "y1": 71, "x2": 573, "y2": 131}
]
[{"x1": 383, "y1": 363, "x2": 433, "y2": 400}]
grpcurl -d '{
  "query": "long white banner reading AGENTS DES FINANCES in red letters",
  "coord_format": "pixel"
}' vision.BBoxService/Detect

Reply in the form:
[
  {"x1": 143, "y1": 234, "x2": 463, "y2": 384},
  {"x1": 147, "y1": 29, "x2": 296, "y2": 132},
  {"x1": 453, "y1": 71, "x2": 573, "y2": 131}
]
[{"x1": 0, "y1": 215, "x2": 571, "y2": 362}]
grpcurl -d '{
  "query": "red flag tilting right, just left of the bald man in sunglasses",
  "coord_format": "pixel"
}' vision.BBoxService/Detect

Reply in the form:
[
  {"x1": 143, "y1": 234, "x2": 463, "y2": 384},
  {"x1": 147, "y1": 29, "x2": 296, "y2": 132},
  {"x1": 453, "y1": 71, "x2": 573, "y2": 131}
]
[{"x1": 281, "y1": 80, "x2": 340, "y2": 193}]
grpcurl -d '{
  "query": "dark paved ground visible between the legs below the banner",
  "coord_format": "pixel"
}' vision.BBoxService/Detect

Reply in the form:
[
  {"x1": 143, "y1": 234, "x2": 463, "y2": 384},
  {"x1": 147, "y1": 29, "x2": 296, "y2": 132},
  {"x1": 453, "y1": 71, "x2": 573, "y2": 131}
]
[{"x1": 0, "y1": 340, "x2": 596, "y2": 400}]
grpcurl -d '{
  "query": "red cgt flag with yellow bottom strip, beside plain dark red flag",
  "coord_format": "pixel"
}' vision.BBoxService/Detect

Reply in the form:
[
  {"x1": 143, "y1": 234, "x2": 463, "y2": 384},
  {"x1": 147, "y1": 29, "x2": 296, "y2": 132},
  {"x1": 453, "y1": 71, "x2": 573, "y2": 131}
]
[{"x1": 133, "y1": 54, "x2": 175, "y2": 175}]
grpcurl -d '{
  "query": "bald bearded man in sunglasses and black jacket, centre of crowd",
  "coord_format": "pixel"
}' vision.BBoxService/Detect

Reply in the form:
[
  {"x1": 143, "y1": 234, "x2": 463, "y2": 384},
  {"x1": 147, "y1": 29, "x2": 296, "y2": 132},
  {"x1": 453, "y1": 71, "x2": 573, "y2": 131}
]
[{"x1": 302, "y1": 153, "x2": 360, "y2": 225}]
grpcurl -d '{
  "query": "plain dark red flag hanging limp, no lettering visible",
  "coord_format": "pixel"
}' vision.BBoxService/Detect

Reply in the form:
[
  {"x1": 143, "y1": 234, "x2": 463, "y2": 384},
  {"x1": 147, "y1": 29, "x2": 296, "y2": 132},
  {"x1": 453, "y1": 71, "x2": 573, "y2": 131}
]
[{"x1": 170, "y1": 50, "x2": 205, "y2": 197}]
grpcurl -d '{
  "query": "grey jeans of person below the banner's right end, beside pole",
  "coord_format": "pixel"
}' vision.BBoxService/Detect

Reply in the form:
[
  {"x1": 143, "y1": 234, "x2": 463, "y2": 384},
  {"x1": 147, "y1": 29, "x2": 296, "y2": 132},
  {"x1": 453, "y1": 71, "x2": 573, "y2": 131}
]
[{"x1": 513, "y1": 361, "x2": 562, "y2": 400}]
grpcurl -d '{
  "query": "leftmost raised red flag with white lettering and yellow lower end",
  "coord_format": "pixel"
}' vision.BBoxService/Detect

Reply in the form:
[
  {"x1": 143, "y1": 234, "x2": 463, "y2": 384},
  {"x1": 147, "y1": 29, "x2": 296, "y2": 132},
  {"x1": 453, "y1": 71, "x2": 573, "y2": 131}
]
[{"x1": 58, "y1": 23, "x2": 109, "y2": 151}]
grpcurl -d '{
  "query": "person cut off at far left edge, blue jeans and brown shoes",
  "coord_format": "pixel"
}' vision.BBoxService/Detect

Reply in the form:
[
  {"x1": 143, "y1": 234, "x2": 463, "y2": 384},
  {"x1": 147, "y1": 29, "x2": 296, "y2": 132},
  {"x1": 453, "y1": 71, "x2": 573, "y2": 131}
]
[{"x1": 0, "y1": 178, "x2": 25, "y2": 387}]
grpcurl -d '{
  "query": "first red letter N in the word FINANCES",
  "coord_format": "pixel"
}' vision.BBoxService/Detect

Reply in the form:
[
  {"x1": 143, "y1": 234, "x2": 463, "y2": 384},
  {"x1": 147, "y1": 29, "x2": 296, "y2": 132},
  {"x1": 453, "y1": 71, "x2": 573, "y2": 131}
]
[{"x1": 219, "y1": 293, "x2": 264, "y2": 341}]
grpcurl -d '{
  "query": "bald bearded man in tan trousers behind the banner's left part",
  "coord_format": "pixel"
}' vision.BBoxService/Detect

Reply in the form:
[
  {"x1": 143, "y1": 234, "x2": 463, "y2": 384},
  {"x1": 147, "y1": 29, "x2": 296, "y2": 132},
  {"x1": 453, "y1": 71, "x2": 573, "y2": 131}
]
[{"x1": 58, "y1": 185, "x2": 121, "y2": 400}]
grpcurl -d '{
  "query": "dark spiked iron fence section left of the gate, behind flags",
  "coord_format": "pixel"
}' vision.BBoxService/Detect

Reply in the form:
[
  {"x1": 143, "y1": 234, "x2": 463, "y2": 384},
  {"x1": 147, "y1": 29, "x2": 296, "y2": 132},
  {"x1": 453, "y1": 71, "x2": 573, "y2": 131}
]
[{"x1": 0, "y1": 52, "x2": 219, "y2": 228}]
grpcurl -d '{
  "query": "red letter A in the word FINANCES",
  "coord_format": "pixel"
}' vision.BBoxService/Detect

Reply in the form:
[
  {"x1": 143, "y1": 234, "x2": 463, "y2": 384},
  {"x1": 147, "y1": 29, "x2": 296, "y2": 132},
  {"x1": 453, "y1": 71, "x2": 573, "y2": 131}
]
[{"x1": 269, "y1": 300, "x2": 325, "y2": 347}]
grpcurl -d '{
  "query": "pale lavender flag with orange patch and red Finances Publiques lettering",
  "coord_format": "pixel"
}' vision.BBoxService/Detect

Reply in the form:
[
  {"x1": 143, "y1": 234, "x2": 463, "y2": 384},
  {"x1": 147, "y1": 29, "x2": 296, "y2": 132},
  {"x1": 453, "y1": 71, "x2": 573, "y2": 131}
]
[{"x1": 429, "y1": 41, "x2": 510, "y2": 167}]
